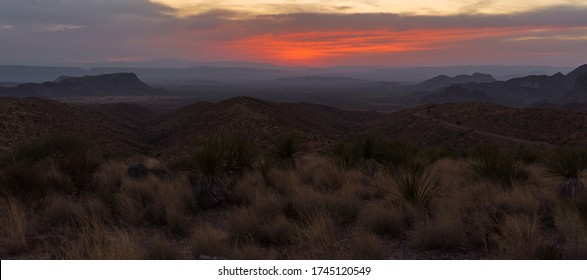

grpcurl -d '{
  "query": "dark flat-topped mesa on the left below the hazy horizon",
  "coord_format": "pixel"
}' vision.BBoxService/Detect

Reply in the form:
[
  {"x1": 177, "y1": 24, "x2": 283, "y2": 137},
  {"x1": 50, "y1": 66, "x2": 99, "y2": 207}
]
[{"x1": 0, "y1": 73, "x2": 164, "y2": 98}]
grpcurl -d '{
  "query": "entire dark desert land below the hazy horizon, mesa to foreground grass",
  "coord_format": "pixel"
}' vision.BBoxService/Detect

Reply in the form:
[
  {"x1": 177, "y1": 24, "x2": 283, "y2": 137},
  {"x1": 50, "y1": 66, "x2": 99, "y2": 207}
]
[{"x1": 0, "y1": 65, "x2": 587, "y2": 259}]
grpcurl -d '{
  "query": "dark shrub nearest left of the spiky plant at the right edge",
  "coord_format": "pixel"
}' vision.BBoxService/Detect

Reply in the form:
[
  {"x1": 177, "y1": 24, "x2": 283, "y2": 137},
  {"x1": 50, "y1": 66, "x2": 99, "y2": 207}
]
[{"x1": 469, "y1": 147, "x2": 529, "y2": 190}]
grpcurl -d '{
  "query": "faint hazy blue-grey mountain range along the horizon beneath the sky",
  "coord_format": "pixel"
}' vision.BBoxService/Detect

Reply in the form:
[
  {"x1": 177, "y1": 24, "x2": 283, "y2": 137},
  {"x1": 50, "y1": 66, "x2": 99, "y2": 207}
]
[{"x1": 0, "y1": 63, "x2": 572, "y2": 86}]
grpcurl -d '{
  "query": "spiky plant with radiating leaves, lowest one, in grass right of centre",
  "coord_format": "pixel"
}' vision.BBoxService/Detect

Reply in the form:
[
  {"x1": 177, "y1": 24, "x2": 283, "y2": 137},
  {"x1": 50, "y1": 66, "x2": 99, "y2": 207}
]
[{"x1": 389, "y1": 163, "x2": 439, "y2": 208}]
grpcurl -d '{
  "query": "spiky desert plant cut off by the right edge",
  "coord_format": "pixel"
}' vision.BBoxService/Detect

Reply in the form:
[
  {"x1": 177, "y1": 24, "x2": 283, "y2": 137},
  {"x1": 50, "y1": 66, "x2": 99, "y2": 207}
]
[{"x1": 543, "y1": 148, "x2": 587, "y2": 198}]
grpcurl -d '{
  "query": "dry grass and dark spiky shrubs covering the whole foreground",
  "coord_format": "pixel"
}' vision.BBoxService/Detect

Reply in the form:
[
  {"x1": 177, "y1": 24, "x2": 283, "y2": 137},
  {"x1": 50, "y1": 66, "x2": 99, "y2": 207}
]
[{"x1": 0, "y1": 135, "x2": 587, "y2": 259}]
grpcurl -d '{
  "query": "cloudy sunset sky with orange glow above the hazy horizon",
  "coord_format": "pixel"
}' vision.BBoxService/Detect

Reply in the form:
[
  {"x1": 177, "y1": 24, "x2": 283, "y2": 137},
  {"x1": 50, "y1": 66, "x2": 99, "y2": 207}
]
[{"x1": 0, "y1": 0, "x2": 587, "y2": 67}]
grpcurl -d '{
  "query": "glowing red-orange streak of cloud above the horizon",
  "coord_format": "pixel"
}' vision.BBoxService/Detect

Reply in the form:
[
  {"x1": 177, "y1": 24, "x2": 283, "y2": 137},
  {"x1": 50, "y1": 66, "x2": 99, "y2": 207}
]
[{"x1": 227, "y1": 27, "x2": 529, "y2": 65}]
